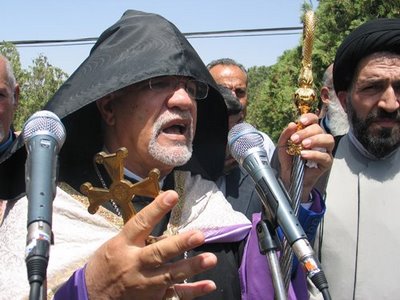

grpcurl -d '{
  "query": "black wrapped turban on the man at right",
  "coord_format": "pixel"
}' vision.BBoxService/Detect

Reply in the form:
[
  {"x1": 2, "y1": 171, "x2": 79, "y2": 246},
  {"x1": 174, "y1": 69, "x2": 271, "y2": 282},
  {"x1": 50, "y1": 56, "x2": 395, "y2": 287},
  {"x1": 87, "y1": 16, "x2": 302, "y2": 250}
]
[{"x1": 333, "y1": 18, "x2": 400, "y2": 93}]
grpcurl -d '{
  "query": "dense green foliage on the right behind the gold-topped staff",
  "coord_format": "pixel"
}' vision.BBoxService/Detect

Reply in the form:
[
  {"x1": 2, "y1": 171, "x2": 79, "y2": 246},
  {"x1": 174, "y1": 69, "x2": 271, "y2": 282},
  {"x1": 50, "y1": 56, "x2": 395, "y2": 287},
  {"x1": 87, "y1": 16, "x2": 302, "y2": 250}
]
[{"x1": 247, "y1": 0, "x2": 400, "y2": 142}]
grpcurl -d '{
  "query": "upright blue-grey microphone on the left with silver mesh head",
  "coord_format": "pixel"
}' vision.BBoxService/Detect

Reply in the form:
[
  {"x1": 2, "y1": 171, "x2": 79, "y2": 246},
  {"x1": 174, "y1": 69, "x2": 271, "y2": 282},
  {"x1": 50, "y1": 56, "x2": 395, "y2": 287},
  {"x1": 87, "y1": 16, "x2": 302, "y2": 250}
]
[{"x1": 22, "y1": 110, "x2": 66, "y2": 298}]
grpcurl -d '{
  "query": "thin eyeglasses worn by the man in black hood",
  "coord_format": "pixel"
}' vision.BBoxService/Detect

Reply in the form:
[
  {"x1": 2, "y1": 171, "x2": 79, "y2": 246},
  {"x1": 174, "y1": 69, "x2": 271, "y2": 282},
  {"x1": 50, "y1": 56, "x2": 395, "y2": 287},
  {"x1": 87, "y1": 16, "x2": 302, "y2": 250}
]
[{"x1": 149, "y1": 76, "x2": 208, "y2": 99}]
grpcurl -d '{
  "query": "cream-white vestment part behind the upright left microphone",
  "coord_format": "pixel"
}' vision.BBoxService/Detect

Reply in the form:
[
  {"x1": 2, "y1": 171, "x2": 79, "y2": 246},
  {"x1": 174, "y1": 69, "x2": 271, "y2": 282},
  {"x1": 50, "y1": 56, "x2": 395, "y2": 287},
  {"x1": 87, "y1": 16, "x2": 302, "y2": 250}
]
[{"x1": 0, "y1": 188, "x2": 119, "y2": 300}]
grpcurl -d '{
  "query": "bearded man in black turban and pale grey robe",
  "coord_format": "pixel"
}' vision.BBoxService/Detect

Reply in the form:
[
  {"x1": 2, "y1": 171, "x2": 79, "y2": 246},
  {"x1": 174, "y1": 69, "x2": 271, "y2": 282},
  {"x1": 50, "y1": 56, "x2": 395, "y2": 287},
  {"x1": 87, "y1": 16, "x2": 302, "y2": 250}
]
[{"x1": 316, "y1": 19, "x2": 400, "y2": 300}]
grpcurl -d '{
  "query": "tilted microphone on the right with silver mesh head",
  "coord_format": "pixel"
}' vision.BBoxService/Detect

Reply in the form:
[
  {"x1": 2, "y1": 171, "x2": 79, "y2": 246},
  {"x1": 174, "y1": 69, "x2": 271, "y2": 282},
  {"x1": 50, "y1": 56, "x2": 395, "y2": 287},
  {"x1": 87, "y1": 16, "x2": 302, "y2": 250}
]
[{"x1": 228, "y1": 122, "x2": 328, "y2": 291}]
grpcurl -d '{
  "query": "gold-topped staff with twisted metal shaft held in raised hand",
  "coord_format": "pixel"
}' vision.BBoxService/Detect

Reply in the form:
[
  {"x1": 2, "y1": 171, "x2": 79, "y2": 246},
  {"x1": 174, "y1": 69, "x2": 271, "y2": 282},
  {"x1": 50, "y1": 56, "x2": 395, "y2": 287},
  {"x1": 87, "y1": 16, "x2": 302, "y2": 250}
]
[{"x1": 280, "y1": 11, "x2": 316, "y2": 289}]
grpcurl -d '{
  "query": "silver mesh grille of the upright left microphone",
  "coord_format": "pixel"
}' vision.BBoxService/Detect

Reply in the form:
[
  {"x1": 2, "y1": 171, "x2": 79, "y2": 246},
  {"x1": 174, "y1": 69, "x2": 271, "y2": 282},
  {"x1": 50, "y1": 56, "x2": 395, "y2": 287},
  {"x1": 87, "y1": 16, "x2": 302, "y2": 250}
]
[{"x1": 22, "y1": 110, "x2": 65, "y2": 148}]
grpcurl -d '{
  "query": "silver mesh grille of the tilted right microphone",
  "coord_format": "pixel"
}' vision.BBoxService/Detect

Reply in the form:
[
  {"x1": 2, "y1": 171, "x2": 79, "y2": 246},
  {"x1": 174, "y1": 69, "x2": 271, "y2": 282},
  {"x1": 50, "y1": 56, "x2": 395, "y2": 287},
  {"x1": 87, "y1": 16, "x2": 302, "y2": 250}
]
[{"x1": 228, "y1": 122, "x2": 264, "y2": 161}]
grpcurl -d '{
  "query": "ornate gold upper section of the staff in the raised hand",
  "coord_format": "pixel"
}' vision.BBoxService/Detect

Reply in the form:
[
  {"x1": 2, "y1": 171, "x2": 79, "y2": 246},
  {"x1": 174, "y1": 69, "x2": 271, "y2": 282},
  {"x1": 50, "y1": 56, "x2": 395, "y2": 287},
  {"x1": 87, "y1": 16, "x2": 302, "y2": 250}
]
[{"x1": 287, "y1": 10, "x2": 317, "y2": 155}]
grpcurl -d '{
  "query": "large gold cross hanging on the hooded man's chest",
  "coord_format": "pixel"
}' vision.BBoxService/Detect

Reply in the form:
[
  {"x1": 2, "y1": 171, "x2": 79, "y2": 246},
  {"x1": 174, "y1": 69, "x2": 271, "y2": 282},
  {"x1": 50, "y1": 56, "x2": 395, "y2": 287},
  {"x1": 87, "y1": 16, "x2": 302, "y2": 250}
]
[{"x1": 80, "y1": 147, "x2": 160, "y2": 223}]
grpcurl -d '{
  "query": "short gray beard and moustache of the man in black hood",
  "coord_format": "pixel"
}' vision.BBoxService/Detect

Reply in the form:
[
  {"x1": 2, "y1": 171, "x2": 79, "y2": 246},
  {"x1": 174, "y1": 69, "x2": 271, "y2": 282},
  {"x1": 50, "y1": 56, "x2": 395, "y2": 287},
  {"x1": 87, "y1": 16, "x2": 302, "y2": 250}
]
[{"x1": 148, "y1": 110, "x2": 194, "y2": 167}]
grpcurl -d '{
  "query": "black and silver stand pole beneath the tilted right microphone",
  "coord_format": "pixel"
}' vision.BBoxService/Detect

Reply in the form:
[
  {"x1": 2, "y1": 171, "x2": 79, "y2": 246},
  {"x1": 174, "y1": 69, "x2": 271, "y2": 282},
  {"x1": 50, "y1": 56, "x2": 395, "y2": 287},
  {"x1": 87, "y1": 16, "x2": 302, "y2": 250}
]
[{"x1": 256, "y1": 212, "x2": 287, "y2": 300}]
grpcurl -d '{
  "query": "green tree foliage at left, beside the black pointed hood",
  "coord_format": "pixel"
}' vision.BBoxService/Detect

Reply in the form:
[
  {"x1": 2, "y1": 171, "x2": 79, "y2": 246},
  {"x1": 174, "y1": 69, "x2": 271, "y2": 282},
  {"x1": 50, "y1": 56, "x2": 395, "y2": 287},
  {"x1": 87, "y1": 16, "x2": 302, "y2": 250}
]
[{"x1": 0, "y1": 43, "x2": 68, "y2": 130}]
